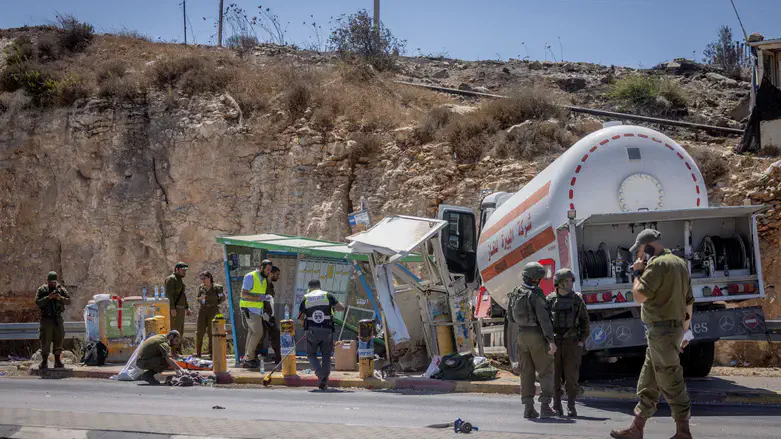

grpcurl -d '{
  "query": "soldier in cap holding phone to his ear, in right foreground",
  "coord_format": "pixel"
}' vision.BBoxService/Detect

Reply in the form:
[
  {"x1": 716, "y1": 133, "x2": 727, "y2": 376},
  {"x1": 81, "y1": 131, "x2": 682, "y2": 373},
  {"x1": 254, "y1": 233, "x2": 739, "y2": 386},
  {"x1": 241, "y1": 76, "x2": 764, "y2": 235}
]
[{"x1": 610, "y1": 229, "x2": 694, "y2": 439}]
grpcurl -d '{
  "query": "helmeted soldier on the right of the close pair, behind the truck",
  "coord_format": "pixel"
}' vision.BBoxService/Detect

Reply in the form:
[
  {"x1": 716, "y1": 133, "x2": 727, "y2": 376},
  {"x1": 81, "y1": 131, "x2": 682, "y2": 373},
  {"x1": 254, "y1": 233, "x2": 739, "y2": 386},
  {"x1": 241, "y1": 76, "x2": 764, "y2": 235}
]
[{"x1": 547, "y1": 268, "x2": 591, "y2": 417}]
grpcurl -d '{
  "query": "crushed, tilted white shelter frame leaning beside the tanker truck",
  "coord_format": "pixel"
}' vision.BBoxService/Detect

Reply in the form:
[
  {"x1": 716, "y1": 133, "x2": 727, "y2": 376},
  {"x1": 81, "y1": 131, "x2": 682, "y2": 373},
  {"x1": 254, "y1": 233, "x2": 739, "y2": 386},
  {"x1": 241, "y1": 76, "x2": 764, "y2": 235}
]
[{"x1": 347, "y1": 215, "x2": 483, "y2": 356}]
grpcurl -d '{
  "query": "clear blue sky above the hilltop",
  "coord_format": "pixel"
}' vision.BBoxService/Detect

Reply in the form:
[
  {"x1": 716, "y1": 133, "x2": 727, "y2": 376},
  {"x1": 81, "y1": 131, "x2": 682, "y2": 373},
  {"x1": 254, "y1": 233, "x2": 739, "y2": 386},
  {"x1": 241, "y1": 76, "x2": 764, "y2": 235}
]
[{"x1": 0, "y1": 0, "x2": 781, "y2": 67}]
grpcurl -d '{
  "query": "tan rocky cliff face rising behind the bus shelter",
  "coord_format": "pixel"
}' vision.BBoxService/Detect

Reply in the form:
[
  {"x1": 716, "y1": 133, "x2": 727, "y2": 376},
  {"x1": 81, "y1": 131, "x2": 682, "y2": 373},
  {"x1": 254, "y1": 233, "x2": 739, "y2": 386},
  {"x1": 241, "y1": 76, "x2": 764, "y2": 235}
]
[{"x1": 0, "y1": 33, "x2": 781, "y2": 360}]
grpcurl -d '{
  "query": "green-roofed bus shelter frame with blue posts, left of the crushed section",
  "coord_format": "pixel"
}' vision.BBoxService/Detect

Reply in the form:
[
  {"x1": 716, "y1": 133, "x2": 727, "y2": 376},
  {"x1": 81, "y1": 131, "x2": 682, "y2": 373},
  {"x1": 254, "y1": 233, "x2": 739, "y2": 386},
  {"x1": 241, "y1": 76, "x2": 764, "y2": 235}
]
[{"x1": 217, "y1": 233, "x2": 422, "y2": 365}]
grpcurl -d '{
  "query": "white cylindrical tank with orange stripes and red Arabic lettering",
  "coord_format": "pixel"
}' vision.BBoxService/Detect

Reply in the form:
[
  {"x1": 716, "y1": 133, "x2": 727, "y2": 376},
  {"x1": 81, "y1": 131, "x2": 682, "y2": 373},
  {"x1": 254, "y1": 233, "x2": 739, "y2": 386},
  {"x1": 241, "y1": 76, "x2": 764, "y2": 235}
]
[{"x1": 477, "y1": 125, "x2": 708, "y2": 309}]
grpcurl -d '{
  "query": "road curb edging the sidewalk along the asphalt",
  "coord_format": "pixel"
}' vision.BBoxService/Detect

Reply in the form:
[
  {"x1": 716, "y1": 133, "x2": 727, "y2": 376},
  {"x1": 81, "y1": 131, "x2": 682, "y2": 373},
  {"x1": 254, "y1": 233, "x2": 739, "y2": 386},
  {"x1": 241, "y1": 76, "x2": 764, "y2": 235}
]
[{"x1": 22, "y1": 367, "x2": 781, "y2": 405}]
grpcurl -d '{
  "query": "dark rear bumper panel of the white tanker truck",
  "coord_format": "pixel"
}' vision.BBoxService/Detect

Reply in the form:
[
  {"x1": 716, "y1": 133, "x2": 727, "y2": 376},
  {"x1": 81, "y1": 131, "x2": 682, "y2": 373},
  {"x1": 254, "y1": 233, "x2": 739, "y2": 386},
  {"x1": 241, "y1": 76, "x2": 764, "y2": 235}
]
[{"x1": 586, "y1": 306, "x2": 767, "y2": 351}]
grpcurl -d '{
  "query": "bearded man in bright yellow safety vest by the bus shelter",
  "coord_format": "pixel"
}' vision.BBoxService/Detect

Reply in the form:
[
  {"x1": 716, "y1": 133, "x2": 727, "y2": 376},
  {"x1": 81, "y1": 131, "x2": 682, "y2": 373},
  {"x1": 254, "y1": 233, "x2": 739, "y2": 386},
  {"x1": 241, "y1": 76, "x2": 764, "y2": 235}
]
[{"x1": 239, "y1": 259, "x2": 272, "y2": 369}]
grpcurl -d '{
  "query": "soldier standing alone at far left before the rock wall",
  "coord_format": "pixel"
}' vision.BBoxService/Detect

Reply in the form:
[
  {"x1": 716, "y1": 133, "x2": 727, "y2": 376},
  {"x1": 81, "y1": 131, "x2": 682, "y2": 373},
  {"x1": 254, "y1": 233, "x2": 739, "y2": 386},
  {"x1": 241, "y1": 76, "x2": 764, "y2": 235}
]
[{"x1": 35, "y1": 271, "x2": 71, "y2": 370}]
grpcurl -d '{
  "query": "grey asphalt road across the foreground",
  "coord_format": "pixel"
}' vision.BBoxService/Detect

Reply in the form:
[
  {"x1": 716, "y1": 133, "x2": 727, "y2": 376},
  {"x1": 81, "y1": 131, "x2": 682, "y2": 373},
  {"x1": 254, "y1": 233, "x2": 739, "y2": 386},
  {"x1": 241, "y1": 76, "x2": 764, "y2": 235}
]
[{"x1": 0, "y1": 379, "x2": 781, "y2": 439}]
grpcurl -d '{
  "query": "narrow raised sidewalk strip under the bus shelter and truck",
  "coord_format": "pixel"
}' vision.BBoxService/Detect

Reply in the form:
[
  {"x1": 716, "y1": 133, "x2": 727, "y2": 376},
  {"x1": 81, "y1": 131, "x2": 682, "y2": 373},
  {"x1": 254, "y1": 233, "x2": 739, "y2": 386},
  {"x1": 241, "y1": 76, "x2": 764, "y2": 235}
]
[{"x1": 12, "y1": 359, "x2": 781, "y2": 405}]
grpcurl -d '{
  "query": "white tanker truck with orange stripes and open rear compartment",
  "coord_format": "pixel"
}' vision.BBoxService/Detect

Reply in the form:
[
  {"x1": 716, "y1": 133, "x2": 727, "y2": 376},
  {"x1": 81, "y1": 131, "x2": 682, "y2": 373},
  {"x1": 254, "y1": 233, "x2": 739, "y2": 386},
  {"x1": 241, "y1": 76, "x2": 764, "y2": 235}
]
[{"x1": 432, "y1": 125, "x2": 765, "y2": 376}]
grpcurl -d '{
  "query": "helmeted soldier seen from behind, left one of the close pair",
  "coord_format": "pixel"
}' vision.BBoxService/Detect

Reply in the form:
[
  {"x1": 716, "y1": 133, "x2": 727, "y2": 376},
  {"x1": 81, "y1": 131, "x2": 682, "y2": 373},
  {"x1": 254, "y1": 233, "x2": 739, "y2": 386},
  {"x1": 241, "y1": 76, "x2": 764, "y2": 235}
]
[{"x1": 507, "y1": 262, "x2": 556, "y2": 418}]
